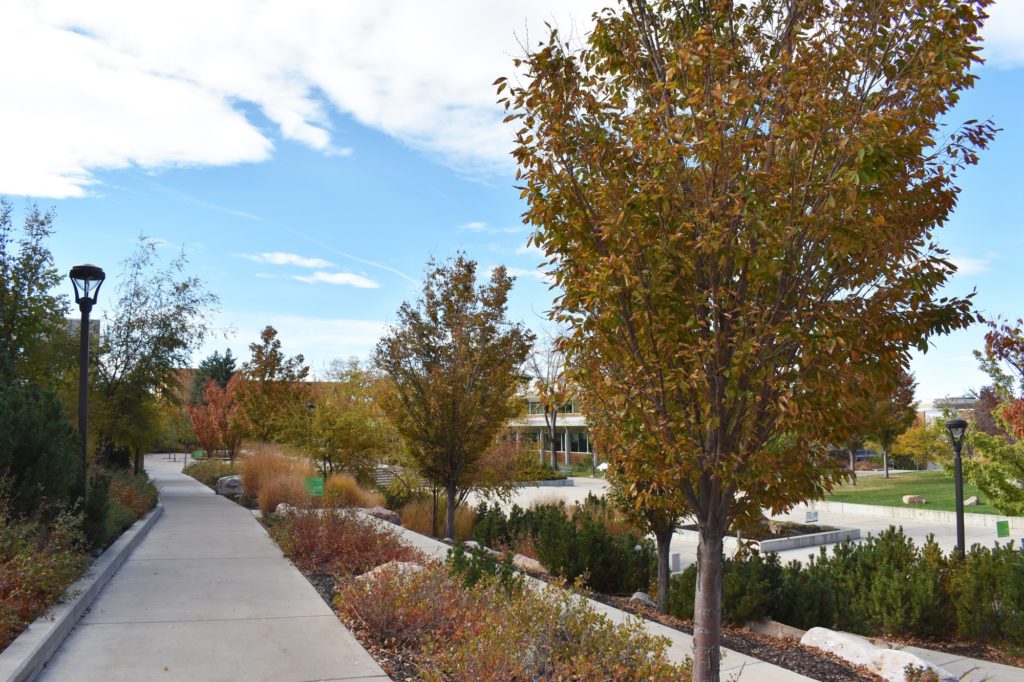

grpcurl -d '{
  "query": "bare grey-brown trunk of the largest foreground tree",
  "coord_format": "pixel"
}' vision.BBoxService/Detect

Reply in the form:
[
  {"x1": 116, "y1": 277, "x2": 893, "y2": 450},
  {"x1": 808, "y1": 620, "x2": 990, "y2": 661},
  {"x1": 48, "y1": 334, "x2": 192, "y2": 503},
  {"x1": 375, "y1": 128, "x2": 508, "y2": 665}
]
[{"x1": 693, "y1": 520, "x2": 725, "y2": 682}]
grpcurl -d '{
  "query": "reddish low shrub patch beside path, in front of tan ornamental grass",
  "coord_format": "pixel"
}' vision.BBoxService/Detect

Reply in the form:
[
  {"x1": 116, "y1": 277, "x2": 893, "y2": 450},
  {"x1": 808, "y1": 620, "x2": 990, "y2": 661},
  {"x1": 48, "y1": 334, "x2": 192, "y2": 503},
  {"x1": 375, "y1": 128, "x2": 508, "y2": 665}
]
[{"x1": 270, "y1": 510, "x2": 426, "y2": 577}]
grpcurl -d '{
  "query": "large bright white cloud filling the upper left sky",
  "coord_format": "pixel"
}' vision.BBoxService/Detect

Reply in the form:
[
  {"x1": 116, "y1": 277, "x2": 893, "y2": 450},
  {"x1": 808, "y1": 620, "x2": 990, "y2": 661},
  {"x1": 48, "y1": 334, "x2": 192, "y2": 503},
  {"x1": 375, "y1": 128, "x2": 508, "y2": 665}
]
[{"x1": 0, "y1": 0, "x2": 601, "y2": 198}]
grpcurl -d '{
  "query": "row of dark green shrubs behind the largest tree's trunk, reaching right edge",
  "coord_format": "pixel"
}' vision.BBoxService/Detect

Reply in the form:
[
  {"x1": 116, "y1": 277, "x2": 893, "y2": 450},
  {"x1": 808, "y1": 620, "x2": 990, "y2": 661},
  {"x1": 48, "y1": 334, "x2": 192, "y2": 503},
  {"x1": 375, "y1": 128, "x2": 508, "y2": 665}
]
[{"x1": 669, "y1": 527, "x2": 1024, "y2": 646}]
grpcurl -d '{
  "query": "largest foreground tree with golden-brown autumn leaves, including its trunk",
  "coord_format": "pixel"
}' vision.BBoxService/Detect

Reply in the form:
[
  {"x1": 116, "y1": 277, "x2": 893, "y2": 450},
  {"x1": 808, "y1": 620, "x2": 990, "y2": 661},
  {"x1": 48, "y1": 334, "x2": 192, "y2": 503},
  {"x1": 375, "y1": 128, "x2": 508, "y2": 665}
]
[{"x1": 507, "y1": 0, "x2": 994, "y2": 682}]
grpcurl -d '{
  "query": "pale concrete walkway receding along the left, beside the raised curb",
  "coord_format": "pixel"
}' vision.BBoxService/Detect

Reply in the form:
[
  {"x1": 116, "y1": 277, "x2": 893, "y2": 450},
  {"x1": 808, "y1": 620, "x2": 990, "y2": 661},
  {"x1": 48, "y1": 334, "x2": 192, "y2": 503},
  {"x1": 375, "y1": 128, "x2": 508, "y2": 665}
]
[{"x1": 39, "y1": 455, "x2": 389, "y2": 682}]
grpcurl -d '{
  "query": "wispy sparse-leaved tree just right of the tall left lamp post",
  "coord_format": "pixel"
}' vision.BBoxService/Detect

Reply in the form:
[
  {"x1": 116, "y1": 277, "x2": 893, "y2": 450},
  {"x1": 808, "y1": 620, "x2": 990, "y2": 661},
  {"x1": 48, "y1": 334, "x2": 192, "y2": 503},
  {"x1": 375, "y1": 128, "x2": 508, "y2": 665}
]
[{"x1": 90, "y1": 235, "x2": 218, "y2": 473}]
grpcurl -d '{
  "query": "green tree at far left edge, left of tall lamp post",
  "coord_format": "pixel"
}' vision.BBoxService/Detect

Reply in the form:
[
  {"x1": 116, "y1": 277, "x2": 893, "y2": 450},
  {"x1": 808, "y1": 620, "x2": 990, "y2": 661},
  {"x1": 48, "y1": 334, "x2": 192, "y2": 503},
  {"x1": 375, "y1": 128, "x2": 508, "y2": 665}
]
[{"x1": 0, "y1": 197, "x2": 77, "y2": 387}]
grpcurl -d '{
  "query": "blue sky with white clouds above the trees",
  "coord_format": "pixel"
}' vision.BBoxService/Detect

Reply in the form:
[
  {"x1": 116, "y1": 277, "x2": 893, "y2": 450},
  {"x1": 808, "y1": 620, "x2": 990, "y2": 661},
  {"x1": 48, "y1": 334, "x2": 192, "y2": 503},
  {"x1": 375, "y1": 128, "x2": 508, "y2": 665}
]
[{"x1": 0, "y1": 0, "x2": 1024, "y2": 400}]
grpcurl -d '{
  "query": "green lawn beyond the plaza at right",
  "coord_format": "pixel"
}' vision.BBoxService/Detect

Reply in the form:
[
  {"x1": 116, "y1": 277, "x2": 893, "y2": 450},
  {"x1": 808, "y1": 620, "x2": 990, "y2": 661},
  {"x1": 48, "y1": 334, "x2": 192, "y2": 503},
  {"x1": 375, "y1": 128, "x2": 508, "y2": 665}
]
[{"x1": 825, "y1": 471, "x2": 999, "y2": 514}]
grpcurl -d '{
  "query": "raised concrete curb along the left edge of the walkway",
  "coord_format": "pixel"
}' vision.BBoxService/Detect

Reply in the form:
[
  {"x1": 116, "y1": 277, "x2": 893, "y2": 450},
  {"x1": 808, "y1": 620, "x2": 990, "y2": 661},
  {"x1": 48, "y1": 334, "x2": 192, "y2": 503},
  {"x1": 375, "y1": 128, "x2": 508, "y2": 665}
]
[{"x1": 0, "y1": 502, "x2": 164, "y2": 682}]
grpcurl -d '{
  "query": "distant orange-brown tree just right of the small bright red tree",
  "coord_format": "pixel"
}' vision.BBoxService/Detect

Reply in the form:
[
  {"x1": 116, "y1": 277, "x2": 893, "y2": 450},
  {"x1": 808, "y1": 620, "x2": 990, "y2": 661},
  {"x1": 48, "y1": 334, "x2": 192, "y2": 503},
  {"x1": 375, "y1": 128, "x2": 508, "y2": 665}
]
[{"x1": 234, "y1": 325, "x2": 309, "y2": 442}]
